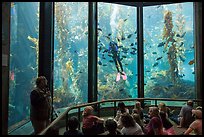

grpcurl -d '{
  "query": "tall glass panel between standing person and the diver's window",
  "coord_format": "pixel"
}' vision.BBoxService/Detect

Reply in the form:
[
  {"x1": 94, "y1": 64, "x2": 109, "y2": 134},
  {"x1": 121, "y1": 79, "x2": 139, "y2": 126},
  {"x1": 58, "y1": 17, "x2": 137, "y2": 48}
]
[{"x1": 53, "y1": 2, "x2": 88, "y2": 108}]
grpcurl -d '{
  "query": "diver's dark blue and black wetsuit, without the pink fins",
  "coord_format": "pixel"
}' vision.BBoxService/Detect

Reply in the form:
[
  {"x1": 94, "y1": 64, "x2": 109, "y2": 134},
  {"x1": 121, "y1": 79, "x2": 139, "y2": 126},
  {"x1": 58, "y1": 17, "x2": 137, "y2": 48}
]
[{"x1": 108, "y1": 41, "x2": 123, "y2": 74}]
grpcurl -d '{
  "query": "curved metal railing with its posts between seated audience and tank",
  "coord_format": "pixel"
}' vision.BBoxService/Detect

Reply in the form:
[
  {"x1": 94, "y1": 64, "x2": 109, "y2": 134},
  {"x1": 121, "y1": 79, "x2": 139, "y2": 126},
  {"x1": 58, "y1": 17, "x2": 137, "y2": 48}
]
[{"x1": 39, "y1": 98, "x2": 202, "y2": 135}]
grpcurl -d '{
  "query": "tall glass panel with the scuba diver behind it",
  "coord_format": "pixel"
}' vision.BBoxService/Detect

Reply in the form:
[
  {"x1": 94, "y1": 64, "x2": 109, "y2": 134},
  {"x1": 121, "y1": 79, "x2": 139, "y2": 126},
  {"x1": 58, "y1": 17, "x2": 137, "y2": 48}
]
[{"x1": 97, "y1": 2, "x2": 138, "y2": 100}]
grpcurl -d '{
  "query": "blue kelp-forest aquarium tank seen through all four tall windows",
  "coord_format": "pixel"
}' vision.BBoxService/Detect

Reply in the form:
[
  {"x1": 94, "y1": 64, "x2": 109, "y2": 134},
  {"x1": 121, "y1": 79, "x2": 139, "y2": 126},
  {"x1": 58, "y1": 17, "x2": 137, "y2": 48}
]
[{"x1": 9, "y1": 2, "x2": 196, "y2": 131}]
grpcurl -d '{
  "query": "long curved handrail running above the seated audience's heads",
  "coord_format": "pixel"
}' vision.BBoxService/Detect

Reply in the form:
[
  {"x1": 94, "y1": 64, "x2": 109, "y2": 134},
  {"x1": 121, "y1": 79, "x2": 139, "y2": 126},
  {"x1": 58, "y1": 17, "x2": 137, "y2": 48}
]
[{"x1": 39, "y1": 98, "x2": 202, "y2": 135}]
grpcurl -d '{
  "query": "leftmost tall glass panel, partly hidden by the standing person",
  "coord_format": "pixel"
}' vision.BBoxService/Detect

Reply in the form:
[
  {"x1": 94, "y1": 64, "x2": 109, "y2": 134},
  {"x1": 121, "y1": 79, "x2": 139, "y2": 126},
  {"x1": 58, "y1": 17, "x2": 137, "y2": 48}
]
[{"x1": 8, "y1": 2, "x2": 39, "y2": 127}]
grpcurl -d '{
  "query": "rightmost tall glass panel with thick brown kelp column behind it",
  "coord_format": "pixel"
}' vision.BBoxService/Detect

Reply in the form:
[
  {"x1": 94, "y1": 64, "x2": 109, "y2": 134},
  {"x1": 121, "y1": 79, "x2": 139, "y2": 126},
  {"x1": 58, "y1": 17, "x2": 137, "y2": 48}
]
[{"x1": 144, "y1": 2, "x2": 195, "y2": 98}]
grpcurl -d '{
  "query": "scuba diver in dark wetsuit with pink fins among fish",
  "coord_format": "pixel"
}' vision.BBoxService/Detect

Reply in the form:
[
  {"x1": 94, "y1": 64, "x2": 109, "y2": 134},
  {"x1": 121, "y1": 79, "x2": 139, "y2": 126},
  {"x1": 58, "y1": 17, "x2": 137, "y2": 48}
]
[{"x1": 108, "y1": 41, "x2": 127, "y2": 81}]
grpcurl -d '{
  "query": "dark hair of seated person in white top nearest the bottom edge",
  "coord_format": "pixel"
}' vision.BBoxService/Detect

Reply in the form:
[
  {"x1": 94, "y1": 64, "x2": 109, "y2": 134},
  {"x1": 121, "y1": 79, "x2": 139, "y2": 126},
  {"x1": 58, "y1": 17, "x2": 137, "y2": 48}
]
[{"x1": 121, "y1": 113, "x2": 135, "y2": 127}]
